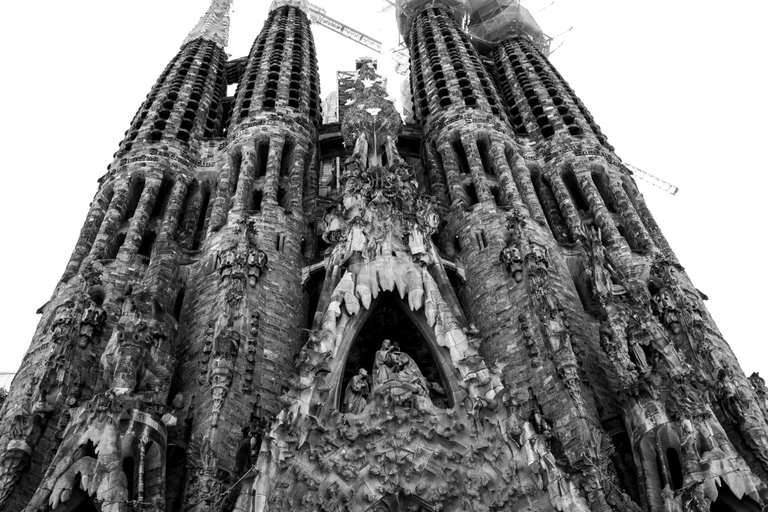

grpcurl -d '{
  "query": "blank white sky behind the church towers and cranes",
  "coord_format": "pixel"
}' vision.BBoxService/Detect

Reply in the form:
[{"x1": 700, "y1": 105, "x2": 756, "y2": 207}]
[{"x1": 0, "y1": 0, "x2": 768, "y2": 375}]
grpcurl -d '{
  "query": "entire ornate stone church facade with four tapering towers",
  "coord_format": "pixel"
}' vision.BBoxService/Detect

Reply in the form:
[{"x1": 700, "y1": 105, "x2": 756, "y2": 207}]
[{"x1": 0, "y1": 0, "x2": 768, "y2": 512}]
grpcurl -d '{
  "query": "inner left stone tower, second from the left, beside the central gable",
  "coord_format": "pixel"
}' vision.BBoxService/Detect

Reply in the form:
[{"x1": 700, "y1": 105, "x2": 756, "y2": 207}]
[{"x1": 180, "y1": 3, "x2": 320, "y2": 510}]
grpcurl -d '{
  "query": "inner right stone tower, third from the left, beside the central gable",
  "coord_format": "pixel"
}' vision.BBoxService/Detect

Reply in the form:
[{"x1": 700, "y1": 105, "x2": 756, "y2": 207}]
[{"x1": 400, "y1": 2, "x2": 632, "y2": 509}]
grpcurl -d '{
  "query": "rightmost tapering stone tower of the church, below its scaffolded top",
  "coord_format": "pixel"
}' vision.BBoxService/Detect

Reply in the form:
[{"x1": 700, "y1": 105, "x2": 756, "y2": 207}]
[{"x1": 486, "y1": 7, "x2": 766, "y2": 510}]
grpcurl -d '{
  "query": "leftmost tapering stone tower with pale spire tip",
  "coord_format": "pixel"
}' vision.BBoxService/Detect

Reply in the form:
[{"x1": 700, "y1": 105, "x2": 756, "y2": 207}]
[{"x1": 0, "y1": 0, "x2": 237, "y2": 511}]
